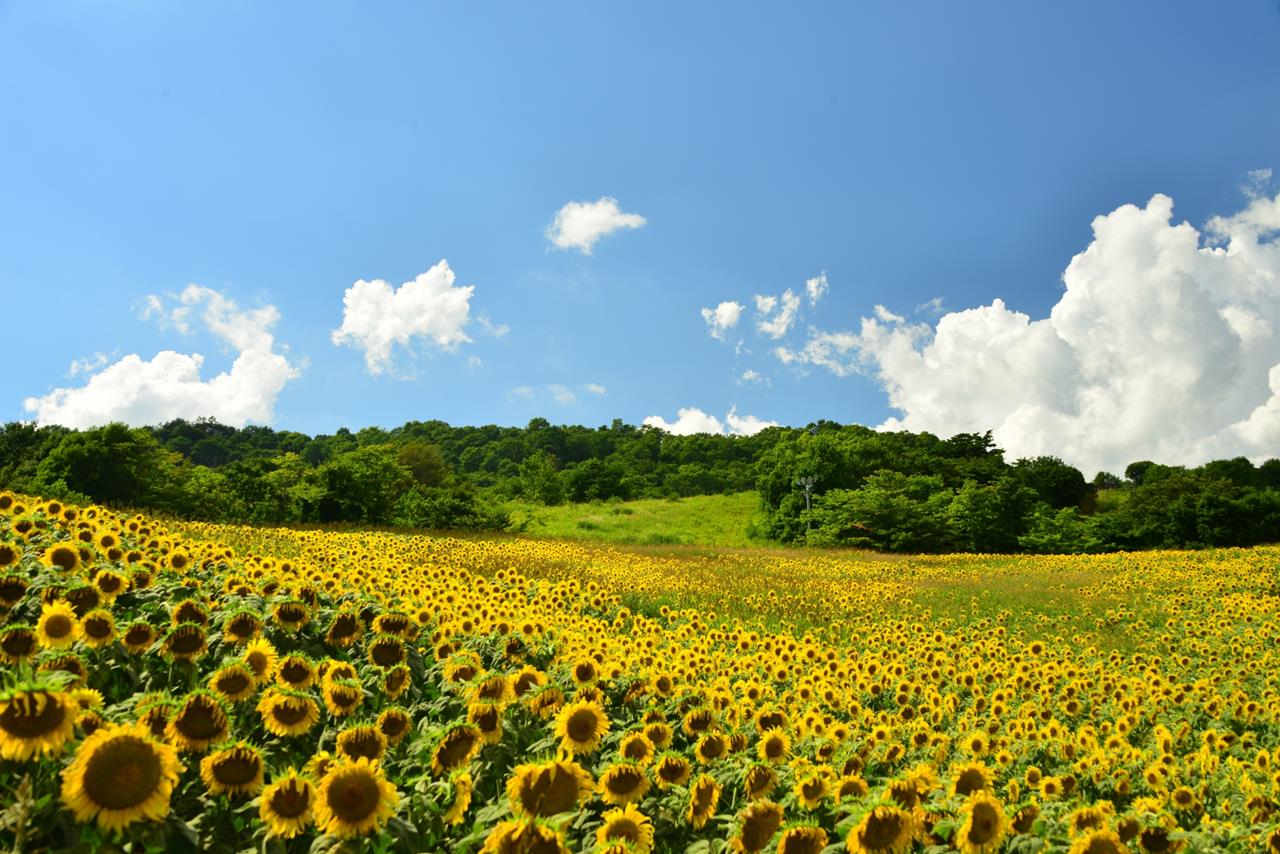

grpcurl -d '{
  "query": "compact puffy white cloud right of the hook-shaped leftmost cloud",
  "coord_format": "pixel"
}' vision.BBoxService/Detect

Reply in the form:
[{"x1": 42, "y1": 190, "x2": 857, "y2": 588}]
[{"x1": 332, "y1": 260, "x2": 476, "y2": 375}]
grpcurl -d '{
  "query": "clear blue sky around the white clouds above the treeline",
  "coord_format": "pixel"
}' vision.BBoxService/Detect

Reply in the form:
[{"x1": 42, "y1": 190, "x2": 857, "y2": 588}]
[{"x1": 0, "y1": 0, "x2": 1280, "y2": 471}]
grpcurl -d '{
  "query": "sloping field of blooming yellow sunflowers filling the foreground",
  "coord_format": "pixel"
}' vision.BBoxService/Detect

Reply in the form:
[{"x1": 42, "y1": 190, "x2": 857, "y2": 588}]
[{"x1": 0, "y1": 493, "x2": 1280, "y2": 854}]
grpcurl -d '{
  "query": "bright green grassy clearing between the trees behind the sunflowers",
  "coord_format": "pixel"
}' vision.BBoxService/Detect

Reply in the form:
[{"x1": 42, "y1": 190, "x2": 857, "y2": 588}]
[{"x1": 507, "y1": 492, "x2": 760, "y2": 548}]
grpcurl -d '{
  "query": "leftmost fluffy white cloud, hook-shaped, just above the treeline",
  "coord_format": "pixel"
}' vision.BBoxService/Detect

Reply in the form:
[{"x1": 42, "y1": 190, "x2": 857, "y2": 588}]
[{"x1": 23, "y1": 284, "x2": 298, "y2": 428}]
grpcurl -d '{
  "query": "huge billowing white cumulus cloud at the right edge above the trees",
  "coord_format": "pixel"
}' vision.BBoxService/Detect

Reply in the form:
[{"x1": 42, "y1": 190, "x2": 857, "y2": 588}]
[{"x1": 778, "y1": 189, "x2": 1280, "y2": 475}]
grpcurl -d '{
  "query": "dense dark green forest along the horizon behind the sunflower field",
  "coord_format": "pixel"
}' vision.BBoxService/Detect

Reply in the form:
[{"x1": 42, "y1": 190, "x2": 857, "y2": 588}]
[{"x1": 0, "y1": 419, "x2": 1280, "y2": 553}]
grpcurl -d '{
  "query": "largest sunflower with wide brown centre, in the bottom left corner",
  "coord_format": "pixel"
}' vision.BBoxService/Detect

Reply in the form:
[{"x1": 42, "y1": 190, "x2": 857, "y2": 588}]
[{"x1": 61, "y1": 723, "x2": 182, "y2": 834}]
